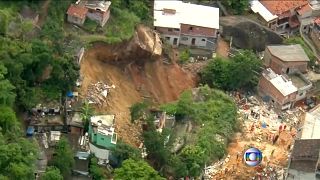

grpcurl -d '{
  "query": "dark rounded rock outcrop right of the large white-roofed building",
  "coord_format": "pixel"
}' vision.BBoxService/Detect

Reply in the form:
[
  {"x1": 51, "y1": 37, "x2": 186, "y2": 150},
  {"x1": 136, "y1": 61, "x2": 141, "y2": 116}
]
[{"x1": 220, "y1": 16, "x2": 282, "y2": 52}]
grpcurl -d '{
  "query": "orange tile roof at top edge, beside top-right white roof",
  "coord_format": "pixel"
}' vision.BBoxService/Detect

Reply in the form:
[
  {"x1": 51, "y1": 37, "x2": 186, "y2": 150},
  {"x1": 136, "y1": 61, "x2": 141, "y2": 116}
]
[{"x1": 260, "y1": 0, "x2": 308, "y2": 15}]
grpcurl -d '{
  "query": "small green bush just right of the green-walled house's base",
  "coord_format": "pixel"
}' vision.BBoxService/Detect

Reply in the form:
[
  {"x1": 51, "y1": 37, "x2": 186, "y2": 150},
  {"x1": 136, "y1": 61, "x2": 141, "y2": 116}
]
[{"x1": 112, "y1": 142, "x2": 141, "y2": 165}]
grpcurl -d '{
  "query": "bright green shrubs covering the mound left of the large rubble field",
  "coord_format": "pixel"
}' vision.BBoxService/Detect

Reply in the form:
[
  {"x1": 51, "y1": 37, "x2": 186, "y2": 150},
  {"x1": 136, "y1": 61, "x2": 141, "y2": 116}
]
[{"x1": 160, "y1": 86, "x2": 238, "y2": 178}]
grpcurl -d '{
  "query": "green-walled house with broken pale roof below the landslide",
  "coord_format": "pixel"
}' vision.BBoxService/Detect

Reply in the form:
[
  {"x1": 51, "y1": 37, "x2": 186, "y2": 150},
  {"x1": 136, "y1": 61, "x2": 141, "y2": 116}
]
[{"x1": 88, "y1": 115, "x2": 117, "y2": 164}]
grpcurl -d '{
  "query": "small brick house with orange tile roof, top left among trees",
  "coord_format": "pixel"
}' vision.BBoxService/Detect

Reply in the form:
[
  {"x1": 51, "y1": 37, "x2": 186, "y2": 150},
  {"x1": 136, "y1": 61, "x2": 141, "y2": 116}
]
[{"x1": 67, "y1": 0, "x2": 111, "y2": 27}]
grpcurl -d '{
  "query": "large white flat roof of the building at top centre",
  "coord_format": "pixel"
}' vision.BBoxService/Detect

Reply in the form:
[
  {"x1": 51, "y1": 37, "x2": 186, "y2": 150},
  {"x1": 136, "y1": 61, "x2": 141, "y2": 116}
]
[{"x1": 153, "y1": 0, "x2": 219, "y2": 29}]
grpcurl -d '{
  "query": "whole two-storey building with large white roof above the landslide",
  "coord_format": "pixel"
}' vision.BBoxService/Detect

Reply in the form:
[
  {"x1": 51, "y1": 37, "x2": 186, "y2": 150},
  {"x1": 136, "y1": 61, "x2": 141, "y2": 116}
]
[{"x1": 154, "y1": 0, "x2": 219, "y2": 54}]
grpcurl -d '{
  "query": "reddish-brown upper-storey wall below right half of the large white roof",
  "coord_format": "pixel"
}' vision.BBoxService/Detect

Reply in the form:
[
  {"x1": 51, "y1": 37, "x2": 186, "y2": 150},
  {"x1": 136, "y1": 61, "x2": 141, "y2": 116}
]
[{"x1": 181, "y1": 24, "x2": 216, "y2": 37}]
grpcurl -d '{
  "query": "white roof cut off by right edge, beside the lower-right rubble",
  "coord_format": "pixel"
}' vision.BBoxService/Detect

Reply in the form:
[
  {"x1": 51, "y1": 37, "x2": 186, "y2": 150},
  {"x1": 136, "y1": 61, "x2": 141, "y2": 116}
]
[{"x1": 301, "y1": 106, "x2": 320, "y2": 139}]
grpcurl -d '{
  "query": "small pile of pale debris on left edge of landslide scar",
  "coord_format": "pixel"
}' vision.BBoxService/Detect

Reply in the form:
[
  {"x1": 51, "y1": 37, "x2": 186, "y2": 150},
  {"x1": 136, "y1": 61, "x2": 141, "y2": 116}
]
[{"x1": 87, "y1": 81, "x2": 115, "y2": 106}]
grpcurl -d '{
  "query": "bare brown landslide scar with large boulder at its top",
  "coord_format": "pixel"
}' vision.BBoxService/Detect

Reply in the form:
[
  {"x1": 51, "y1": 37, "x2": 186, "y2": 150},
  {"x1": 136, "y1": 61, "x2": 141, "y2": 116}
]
[{"x1": 80, "y1": 26, "x2": 196, "y2": 146}]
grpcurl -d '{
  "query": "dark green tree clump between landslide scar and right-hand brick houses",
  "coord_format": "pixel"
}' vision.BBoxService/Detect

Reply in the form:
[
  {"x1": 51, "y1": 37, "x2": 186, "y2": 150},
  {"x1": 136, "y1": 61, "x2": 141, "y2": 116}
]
[{"x1": 201, "y1": 50, "x2": 262, "y2": 90}]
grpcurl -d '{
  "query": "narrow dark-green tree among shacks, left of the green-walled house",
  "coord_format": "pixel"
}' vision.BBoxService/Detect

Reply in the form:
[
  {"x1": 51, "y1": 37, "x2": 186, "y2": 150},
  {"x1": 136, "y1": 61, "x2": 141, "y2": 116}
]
[{"x1": 50, "y1": 138, "x2": 74, "y2": 177}]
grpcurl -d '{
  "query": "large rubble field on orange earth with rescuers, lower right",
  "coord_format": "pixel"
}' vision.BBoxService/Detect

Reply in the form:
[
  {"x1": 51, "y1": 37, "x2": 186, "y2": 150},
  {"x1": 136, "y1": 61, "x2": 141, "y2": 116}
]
[{"x1": 204, "y1": 92, "x2": 304, "y2": 179}]
